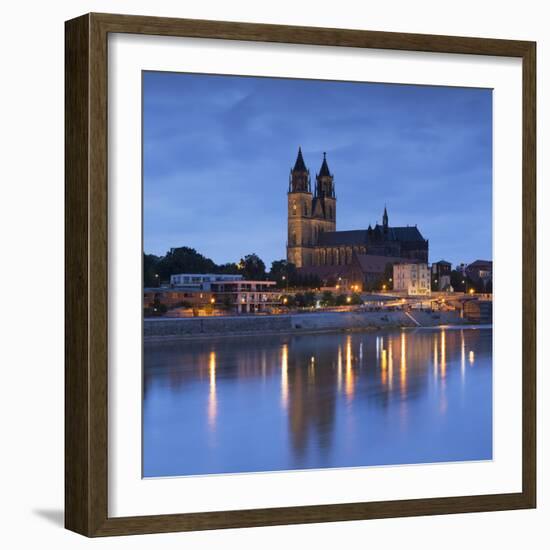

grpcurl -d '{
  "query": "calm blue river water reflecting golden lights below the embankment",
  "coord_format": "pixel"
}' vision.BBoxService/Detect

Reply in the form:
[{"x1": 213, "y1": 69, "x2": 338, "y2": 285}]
[{"x1": 143, "y1": 328, "x2": 492, "y2": 477}]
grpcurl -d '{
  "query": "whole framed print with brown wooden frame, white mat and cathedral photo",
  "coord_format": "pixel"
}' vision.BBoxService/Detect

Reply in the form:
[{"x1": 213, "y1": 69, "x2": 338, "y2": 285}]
[{"x1": 65, "y1": 14, "x2": 536, "y2": 536}]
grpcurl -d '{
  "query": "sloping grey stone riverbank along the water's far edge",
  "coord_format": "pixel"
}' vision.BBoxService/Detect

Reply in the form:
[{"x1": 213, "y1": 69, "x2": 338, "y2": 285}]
[{"x1": 143, "y1": 311, "x2": 476, "y2": 340}]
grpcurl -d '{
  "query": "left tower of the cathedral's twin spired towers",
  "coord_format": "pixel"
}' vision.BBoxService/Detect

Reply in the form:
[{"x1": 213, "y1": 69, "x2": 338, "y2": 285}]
[{"x1": 286, "y1": 147, "x2": 314, "y2": 267}]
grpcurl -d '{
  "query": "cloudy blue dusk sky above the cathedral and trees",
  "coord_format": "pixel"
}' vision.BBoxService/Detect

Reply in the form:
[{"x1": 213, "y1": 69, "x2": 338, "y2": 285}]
[{"x1": 143, "y1": 72, "x2": 492, "y2": 268}]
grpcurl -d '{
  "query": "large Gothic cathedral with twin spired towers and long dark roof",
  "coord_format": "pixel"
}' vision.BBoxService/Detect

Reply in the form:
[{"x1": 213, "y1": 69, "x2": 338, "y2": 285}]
[{"x1": 287, "y1": 148, "x2": 428, "y2": 272}]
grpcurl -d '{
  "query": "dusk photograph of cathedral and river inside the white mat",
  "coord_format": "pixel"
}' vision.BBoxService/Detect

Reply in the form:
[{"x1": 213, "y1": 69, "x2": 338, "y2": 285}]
[{"x1": 143, "y1": 70, "x2": 496, "y2": 478}]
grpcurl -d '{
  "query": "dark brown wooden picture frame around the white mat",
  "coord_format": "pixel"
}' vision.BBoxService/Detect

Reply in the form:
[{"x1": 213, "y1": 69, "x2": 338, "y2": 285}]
[{"x1": 65, "y1": 14, "x2": 536, "y2": 537}]
